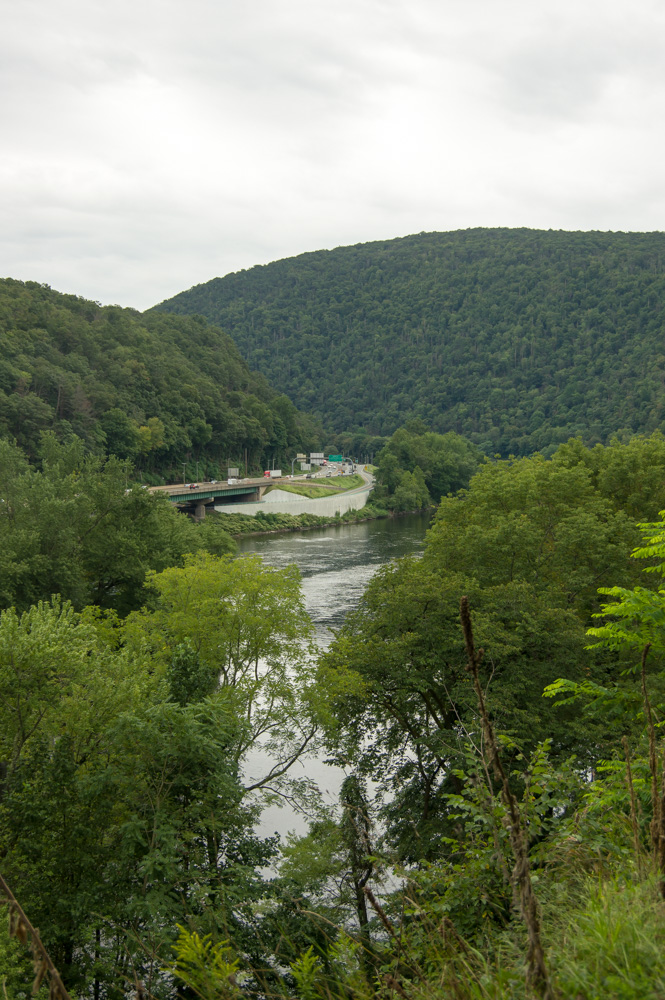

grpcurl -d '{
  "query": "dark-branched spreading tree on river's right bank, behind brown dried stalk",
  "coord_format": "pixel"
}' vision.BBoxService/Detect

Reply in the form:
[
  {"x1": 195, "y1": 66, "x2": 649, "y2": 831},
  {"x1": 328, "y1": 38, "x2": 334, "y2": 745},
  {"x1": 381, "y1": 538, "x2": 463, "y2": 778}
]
[{"x1": 321, "y1": 559, "x2": 593, "y2": 861}]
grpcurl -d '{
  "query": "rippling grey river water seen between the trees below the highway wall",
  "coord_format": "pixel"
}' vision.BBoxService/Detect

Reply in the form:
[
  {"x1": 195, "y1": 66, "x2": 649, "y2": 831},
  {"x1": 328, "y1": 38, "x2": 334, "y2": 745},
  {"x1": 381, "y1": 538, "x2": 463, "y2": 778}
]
[{"x1": 238, "y1": 514, "x2": 429, "y2": 836}]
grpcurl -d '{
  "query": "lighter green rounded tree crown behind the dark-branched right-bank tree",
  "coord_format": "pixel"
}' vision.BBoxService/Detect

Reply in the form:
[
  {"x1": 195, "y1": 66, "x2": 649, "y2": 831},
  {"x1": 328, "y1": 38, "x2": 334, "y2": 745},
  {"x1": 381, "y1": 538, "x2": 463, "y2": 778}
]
[{"x1": 426, "y1": 455, "x2": 637, "y2": 616}]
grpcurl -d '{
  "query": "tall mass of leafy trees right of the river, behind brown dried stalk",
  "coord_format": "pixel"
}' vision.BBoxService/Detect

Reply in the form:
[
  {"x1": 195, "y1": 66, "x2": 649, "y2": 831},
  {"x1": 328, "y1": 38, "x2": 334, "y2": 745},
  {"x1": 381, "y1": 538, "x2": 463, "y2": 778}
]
[{"x1": 321, "y1": 439, "x2": 662, "y2": 862}]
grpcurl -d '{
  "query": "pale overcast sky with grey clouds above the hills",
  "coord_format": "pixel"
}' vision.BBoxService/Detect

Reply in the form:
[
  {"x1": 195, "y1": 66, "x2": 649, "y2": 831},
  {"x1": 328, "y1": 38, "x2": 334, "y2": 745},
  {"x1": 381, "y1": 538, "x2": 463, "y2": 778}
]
[{"x1": 0, "y1": 0, "x2": 665, "y2": 309}]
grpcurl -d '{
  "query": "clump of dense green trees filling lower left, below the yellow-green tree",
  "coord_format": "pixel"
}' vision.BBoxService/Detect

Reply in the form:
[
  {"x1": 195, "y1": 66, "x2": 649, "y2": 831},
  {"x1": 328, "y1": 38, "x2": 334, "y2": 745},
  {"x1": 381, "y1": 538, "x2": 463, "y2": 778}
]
[{"x1": 0, "y1": 601, "x2": 274, "y2": 997}]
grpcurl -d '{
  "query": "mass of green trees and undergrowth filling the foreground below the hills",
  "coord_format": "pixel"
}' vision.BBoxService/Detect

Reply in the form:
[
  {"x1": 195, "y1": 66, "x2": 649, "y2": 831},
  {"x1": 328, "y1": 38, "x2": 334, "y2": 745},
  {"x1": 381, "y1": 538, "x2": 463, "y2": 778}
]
[{"x1": 6, "y1": 434, "x2": 665, "y2": 1000}]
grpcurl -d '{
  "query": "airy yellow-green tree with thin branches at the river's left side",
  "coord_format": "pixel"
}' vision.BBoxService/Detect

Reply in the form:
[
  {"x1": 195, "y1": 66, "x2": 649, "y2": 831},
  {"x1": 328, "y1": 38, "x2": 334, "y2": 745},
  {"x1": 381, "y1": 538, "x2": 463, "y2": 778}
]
[{"x1": 126, "y1": 552, "x2": 317, "y2": 808}]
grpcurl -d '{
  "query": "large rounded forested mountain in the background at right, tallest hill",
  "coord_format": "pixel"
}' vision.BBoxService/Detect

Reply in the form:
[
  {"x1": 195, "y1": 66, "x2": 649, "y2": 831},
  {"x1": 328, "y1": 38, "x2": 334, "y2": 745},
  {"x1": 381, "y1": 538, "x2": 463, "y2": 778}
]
[{"x1": 156, "y1": 229, "x2": 665, "y2": 454}]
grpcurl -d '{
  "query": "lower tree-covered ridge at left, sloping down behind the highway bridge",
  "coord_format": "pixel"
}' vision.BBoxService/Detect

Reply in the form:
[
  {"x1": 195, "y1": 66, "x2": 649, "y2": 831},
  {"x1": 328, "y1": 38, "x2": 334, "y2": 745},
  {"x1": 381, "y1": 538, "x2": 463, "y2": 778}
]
[{"x1": 0, "y1": 279, "x2": 316, "y2": 478}]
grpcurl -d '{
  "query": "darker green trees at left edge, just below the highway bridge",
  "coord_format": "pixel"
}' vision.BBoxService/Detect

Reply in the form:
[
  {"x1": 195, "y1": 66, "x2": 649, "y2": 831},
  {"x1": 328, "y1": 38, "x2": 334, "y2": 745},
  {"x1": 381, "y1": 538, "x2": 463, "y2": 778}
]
[{"x1": 0, "y1": 434, "x2": 233, "y2": 614}]
